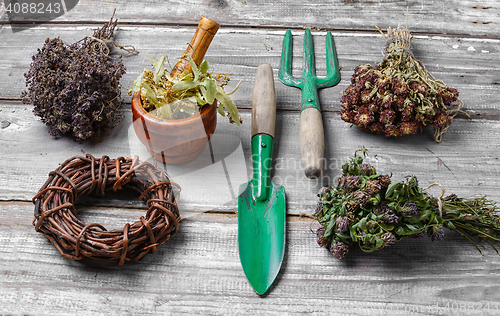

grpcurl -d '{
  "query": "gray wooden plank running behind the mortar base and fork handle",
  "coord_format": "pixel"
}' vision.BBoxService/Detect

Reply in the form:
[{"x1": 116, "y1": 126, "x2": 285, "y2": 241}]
[{"x1": 0, "y1": 99, "x2": 500, "y2": 214}]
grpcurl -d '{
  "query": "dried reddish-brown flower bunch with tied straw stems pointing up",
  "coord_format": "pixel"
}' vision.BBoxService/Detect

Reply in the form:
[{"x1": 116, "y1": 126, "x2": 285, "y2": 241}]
[{"x1": 340, "y1": 26, "x2": 468, "y2": 143}]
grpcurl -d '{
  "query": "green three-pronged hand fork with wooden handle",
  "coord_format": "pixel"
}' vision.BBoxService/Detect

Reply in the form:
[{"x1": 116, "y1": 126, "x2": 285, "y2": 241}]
[{"x1": 278, "y1": 29, "x2": 340, "y2": 179}]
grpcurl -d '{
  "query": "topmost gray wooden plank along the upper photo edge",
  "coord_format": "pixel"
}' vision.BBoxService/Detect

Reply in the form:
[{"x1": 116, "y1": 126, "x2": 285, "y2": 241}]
[{"x1": 0, "y1": 0, "x2": 499, "y2": 35}]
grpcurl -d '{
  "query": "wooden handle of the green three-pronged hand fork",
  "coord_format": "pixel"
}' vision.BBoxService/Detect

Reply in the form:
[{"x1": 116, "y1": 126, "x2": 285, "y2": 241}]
[{"x1": 300, "y1": 108, "x2": 325, "y2": 179}]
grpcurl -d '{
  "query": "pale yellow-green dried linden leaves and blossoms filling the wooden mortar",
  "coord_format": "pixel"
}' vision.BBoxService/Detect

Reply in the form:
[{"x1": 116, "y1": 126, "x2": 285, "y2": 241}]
[{"x1": 129, "y1": 55, "x2": 241, "y2": 125}]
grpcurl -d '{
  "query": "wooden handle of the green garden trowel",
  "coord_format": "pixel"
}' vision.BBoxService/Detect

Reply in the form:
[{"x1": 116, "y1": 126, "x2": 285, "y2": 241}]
[{"x1": 252, "y1": 64, "x2": 276, "y2": 137}]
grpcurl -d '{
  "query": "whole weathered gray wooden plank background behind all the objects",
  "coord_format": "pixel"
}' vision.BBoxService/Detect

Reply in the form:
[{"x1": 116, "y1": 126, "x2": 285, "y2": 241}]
[{"x1": 0, "y1": 0, "x2": 500, "y2": 315}]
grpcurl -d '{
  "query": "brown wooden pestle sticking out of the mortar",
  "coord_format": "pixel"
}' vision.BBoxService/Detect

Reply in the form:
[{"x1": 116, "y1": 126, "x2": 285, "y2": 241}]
[{"x1": 170, "y1": 16, "x2": 219, "y2": 77}]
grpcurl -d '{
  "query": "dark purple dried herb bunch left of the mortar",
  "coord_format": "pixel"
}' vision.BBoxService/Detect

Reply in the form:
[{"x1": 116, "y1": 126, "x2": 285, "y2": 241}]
[{"x1": 21, "y1": 14, "x2": 131, "y2": 140}]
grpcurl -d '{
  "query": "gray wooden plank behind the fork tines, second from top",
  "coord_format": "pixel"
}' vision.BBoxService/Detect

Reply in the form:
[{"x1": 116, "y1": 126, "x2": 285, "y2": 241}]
[{"x1": 0, "y1": 25, "x2": 500, "y2": 115}]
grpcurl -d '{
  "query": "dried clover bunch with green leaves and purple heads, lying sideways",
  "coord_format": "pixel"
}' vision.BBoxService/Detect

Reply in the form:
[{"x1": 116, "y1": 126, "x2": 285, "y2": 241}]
[{"x1": 315, "y1": 148, "x2": 500, "y2": 259}]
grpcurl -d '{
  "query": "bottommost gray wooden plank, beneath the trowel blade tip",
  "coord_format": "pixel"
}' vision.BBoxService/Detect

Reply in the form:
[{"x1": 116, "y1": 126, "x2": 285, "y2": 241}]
[{"x1": 0, "y1": 202, "x2": 500, "y2": 315}]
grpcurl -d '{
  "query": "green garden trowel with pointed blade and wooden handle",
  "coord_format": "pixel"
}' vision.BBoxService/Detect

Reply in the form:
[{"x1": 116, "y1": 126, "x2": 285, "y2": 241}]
[{"x1": 238, "y1": 64, "x2": 286, "y2": 295}]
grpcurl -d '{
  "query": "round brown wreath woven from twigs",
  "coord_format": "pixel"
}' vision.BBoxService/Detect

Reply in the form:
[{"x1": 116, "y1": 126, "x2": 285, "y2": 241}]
[{"x1": 33, "y1": 155, "x2": 181, "y2": 265}]
